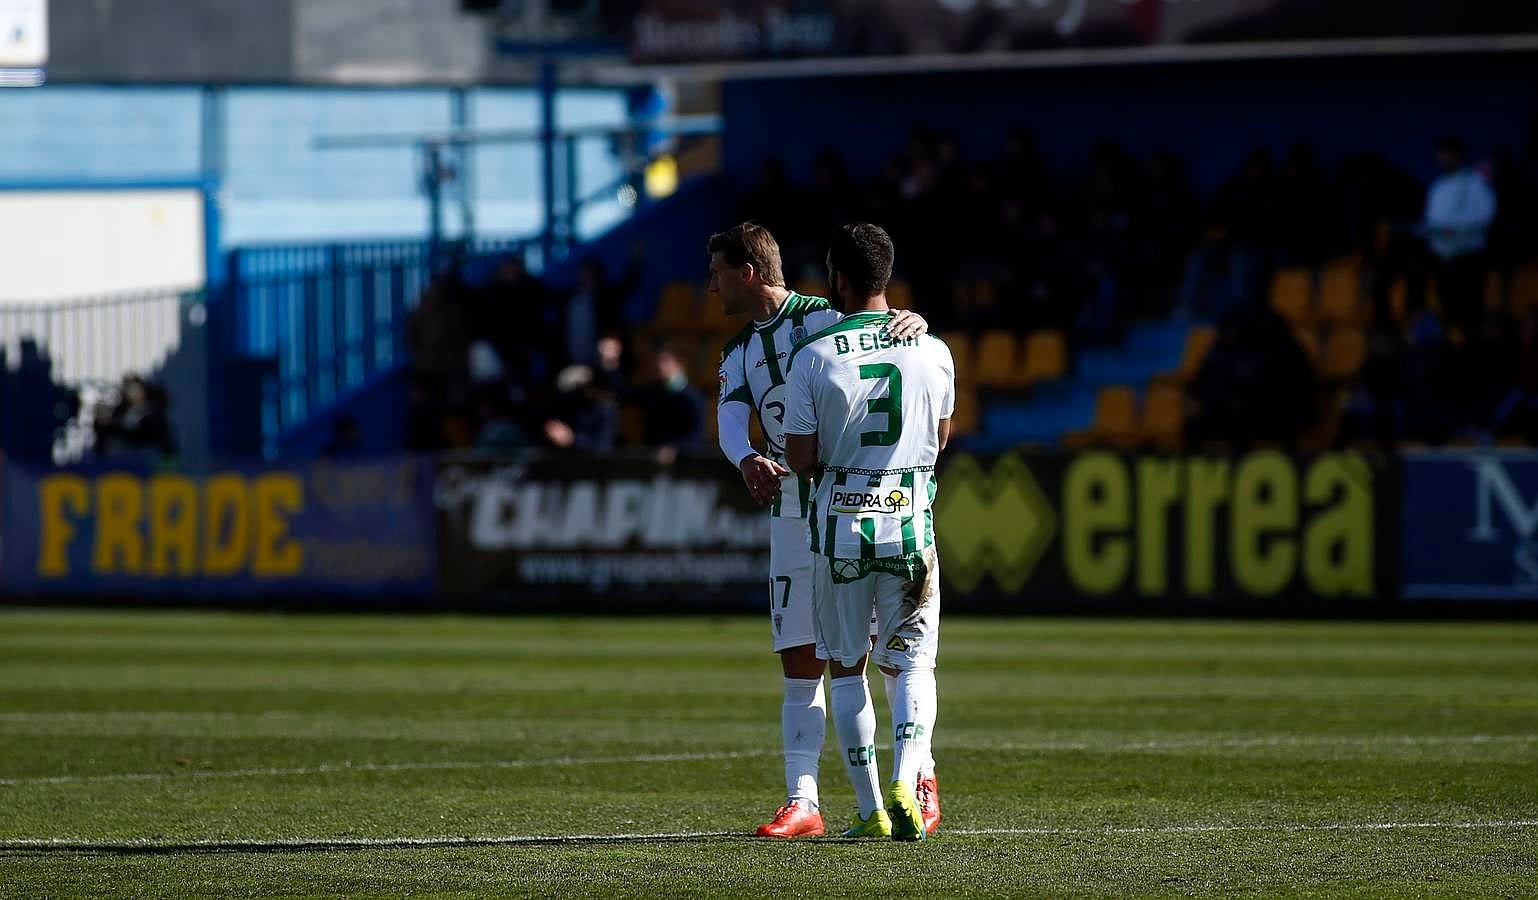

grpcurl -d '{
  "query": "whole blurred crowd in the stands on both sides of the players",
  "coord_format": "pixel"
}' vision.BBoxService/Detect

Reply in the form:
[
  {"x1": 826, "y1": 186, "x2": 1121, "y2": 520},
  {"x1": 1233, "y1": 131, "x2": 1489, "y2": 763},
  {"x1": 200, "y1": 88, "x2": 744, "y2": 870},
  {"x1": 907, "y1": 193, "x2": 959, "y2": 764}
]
[{"x1": 408, "y1": 119, "x2": 1538, "y2": 457}]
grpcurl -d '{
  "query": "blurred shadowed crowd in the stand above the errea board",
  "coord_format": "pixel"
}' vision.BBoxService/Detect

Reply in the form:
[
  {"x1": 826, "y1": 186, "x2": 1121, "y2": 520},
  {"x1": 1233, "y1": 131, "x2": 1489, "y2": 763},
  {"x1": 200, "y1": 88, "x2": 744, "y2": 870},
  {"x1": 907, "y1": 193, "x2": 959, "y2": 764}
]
[{"x1": 740, "y1": 118, "x2": 1538, "y2": 445}]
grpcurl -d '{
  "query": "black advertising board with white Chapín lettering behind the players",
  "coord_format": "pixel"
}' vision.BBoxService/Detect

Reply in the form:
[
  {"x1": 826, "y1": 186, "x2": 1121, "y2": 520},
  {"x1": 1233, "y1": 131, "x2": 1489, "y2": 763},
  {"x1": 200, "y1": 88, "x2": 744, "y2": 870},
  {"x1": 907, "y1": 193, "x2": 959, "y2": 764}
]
[{"x1": 437, "y1": 457, "x2": 769, "y2": 603}]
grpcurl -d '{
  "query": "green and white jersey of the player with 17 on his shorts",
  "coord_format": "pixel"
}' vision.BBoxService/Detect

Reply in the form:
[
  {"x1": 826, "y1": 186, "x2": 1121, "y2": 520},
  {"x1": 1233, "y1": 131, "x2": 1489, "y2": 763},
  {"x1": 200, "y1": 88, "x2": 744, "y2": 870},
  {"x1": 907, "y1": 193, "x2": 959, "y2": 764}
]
[{"x1": 720, "y1": 291, "x2": 841, "y2": 518}]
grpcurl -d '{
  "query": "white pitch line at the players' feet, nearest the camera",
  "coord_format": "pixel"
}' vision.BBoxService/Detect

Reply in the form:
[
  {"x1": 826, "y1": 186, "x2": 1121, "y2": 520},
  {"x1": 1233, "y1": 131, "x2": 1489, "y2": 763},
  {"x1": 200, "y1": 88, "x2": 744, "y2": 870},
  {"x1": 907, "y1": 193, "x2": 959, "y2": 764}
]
[{"x1": 0, "y1": 818, "x2": 1538, "y2": 852}]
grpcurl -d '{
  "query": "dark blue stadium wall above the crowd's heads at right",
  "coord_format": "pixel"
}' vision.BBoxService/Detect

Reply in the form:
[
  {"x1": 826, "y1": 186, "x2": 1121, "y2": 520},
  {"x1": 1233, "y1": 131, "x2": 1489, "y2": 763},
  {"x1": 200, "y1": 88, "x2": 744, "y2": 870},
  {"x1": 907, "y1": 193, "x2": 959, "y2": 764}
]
[{"x1": 721, "y1": 52, "x2": 1538, "y2": 192}]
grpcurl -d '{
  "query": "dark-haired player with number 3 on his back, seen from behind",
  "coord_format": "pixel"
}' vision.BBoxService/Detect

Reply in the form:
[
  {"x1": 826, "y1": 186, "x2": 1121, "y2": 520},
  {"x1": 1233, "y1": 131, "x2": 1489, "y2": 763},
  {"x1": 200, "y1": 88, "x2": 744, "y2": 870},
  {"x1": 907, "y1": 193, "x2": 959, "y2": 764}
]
[{"x1": 784, "y1": 225, "x2": 955, "y2": 840}]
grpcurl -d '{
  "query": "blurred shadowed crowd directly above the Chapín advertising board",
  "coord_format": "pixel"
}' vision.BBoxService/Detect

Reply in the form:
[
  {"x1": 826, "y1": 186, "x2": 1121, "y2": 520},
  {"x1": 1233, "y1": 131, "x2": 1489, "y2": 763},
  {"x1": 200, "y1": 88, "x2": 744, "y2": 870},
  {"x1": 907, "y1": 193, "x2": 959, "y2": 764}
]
[{"x1": 406, "y1": 246, "x2": 706, "y2": 460}]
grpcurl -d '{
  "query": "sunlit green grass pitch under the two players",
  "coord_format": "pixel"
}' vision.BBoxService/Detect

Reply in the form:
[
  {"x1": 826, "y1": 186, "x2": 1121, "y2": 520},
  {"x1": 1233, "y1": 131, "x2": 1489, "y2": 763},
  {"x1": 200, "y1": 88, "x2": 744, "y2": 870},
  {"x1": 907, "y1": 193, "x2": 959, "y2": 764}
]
[{"x1": 0, "y1": 611, "x2": 1538, "y2": 897}]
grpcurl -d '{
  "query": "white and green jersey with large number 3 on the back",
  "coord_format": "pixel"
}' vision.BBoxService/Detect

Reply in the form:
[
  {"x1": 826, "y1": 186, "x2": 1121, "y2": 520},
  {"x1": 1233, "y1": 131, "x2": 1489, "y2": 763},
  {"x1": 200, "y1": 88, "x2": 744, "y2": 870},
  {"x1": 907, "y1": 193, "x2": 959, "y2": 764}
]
[{"x1": 784, "y1": 312, "x2": 955, "y2": 560}]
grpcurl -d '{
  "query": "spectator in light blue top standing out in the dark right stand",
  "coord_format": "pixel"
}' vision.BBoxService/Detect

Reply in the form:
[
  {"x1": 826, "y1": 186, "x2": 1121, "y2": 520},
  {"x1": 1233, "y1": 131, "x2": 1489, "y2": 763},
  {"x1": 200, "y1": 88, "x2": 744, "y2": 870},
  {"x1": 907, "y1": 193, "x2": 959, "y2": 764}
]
[{"x1": 1421, "y1": 137, "x2": 1495, "y2": 334}]
